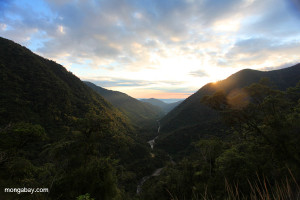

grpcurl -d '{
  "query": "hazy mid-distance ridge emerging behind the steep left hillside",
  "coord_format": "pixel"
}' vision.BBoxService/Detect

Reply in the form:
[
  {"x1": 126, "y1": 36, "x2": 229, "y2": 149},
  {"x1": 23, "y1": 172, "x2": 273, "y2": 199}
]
[{"x1": 85, "y1": 82, "x2": 163, "y2": 128}]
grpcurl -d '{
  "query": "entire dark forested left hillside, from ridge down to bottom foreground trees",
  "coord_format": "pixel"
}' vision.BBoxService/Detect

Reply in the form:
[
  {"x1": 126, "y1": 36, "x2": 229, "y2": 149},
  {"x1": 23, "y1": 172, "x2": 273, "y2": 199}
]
[{"x1": 0, "y1": 38, "x2": 161, "y2": 199}]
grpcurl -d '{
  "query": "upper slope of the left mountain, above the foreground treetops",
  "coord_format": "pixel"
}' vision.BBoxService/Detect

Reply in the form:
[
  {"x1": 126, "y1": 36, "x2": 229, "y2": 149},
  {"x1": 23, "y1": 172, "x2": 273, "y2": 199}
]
[{"x1": 0, "y1": 38, "x2": 129, "y2": 135}]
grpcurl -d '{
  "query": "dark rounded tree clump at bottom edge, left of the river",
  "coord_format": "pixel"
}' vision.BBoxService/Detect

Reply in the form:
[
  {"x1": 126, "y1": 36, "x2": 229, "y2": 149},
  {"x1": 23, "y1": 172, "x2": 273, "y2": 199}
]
[{"x1": 51, "y1": 157, "x2": 120, "y2": 200}]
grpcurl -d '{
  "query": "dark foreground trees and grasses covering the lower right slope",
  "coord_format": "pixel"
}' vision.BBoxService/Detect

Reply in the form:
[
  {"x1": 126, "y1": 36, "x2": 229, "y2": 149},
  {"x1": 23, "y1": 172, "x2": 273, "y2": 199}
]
[{"x1": 142, "y1": 80, "x2": 300, "y2": 199}]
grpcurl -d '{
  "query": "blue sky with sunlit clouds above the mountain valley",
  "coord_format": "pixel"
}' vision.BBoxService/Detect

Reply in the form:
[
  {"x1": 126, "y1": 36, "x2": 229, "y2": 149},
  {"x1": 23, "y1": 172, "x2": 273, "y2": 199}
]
[{"x1": 0, "y1": 0, "x2": 300, "y2": 99}]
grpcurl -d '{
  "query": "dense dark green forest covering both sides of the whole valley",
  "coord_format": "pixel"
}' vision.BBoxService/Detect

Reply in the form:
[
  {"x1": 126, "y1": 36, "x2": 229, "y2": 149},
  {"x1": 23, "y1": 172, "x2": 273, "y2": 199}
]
[{"x1": 0, "y1": 38, "x2": 300, "y2": 200}]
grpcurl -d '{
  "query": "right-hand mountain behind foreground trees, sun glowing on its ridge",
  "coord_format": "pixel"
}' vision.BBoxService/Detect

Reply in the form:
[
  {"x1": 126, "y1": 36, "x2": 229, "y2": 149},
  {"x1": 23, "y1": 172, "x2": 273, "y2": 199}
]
[{"x1": 158, "y1": 64, "x2": 300, "y2": 152}]
